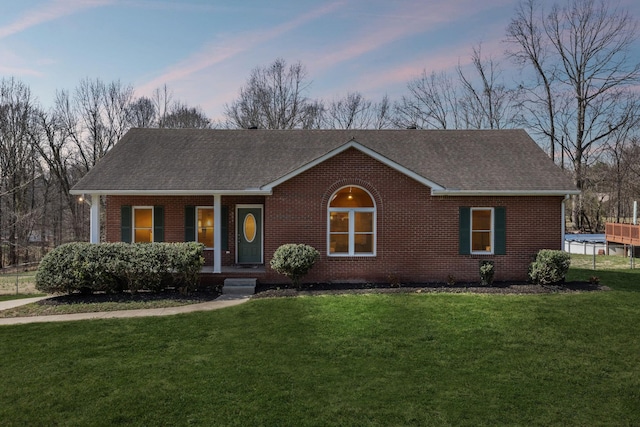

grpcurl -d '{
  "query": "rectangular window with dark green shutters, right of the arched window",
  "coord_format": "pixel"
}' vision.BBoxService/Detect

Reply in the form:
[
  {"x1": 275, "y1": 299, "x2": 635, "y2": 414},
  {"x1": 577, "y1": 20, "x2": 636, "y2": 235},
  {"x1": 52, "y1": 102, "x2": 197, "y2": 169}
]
[{"x1": 459, "y1": 206, "x2": 507, "y2": 255}]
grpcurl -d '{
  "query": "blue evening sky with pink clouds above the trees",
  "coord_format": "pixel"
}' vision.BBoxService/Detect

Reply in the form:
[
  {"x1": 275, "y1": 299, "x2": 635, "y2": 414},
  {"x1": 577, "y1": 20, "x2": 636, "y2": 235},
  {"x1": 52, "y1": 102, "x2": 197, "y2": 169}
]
[{"x1": 0, "y1": 0, "x2": 640, "y2": 120}]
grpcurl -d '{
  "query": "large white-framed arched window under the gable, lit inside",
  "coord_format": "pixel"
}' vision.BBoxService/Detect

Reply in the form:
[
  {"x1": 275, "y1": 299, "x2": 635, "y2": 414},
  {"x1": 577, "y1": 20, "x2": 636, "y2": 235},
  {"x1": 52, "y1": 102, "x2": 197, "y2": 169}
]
[{"x1": 327, "y1": 186, "x2": 376, "y2": 256}]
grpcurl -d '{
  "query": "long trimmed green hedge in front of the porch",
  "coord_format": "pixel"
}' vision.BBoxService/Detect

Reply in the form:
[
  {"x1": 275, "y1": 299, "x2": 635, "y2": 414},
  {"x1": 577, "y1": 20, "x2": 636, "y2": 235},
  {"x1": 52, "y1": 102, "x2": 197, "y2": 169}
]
[{"x1": 36, "y1": 242, "x2": 204, "y2": 293}]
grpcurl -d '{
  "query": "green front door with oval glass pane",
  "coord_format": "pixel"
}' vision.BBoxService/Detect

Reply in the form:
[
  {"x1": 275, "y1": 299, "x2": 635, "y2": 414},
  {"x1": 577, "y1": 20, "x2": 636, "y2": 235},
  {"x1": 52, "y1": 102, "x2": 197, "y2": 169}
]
[{"x1": 236, "y1": 205, "x2": 264, "y2": 264}]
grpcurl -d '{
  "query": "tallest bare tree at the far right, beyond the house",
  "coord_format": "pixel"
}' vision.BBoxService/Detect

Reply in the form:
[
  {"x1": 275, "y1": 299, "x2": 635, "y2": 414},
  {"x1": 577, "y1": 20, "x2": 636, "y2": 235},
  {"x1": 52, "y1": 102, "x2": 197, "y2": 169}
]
[{"x1": 545, "y1": 0, "x2": 640, "y2": 227}]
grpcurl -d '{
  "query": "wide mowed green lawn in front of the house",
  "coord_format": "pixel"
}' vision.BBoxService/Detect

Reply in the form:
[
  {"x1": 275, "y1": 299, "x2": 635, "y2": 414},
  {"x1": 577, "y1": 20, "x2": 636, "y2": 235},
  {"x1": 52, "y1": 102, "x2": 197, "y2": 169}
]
[{"x1": 0, "y1": 263, "x2": 640, "y2": 426}]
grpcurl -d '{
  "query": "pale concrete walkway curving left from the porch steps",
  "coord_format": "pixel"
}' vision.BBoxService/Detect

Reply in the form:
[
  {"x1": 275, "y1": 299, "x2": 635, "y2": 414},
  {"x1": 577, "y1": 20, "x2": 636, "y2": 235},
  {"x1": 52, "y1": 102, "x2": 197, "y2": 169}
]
[{"x1": 0, "y1": 295, "x2": 249, "y2": 325}]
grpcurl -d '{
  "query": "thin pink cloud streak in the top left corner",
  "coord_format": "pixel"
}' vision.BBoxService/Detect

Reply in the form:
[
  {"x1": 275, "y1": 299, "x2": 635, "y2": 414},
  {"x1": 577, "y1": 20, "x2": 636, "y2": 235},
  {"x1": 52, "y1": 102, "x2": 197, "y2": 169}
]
[{"x1": 0, "y1": 0, "x2": 113, "y2": 39}]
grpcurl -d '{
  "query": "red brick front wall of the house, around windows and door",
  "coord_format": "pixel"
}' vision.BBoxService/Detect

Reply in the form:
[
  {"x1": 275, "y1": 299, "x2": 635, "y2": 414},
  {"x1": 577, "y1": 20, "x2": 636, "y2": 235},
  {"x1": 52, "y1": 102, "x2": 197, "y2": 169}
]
[{"x1": 106, "y1": 149, "x2": 562, "y2": 283}]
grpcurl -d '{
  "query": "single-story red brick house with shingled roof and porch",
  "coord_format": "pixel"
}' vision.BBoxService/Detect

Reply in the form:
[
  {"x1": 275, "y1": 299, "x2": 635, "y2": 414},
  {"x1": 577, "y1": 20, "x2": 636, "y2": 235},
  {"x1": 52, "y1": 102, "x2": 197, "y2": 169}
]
[{"x1": 71, "y1": 129, "x2": 578, "y2": 283}]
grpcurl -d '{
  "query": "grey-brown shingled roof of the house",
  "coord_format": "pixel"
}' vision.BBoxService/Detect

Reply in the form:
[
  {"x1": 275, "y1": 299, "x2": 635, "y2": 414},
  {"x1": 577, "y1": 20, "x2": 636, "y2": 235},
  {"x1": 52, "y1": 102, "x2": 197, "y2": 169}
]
[{"x1": 72, "y1": 129, "x2": 577, "y2": 195}]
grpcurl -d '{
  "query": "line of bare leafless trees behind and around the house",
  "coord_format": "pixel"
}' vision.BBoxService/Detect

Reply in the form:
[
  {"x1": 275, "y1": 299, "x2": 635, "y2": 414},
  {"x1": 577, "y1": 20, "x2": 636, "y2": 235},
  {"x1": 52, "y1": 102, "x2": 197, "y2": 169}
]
[{"x1": 0, "y1": 0, "x2": 640, "y2": 267}]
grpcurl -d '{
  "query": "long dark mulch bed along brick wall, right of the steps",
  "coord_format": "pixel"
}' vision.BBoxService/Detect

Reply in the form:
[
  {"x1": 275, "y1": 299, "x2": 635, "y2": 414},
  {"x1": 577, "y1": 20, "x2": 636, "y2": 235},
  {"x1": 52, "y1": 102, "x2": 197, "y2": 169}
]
[{"x1": 252, "y1": 282, "x2": 610, "y2": 298}]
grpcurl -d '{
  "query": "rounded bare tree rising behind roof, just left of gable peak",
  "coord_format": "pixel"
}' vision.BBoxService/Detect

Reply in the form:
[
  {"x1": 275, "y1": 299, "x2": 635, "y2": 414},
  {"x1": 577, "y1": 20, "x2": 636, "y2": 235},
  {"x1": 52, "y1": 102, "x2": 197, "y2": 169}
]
[{"x1": 225, "y1": 58, "x2": 318, "y2": 129}]
